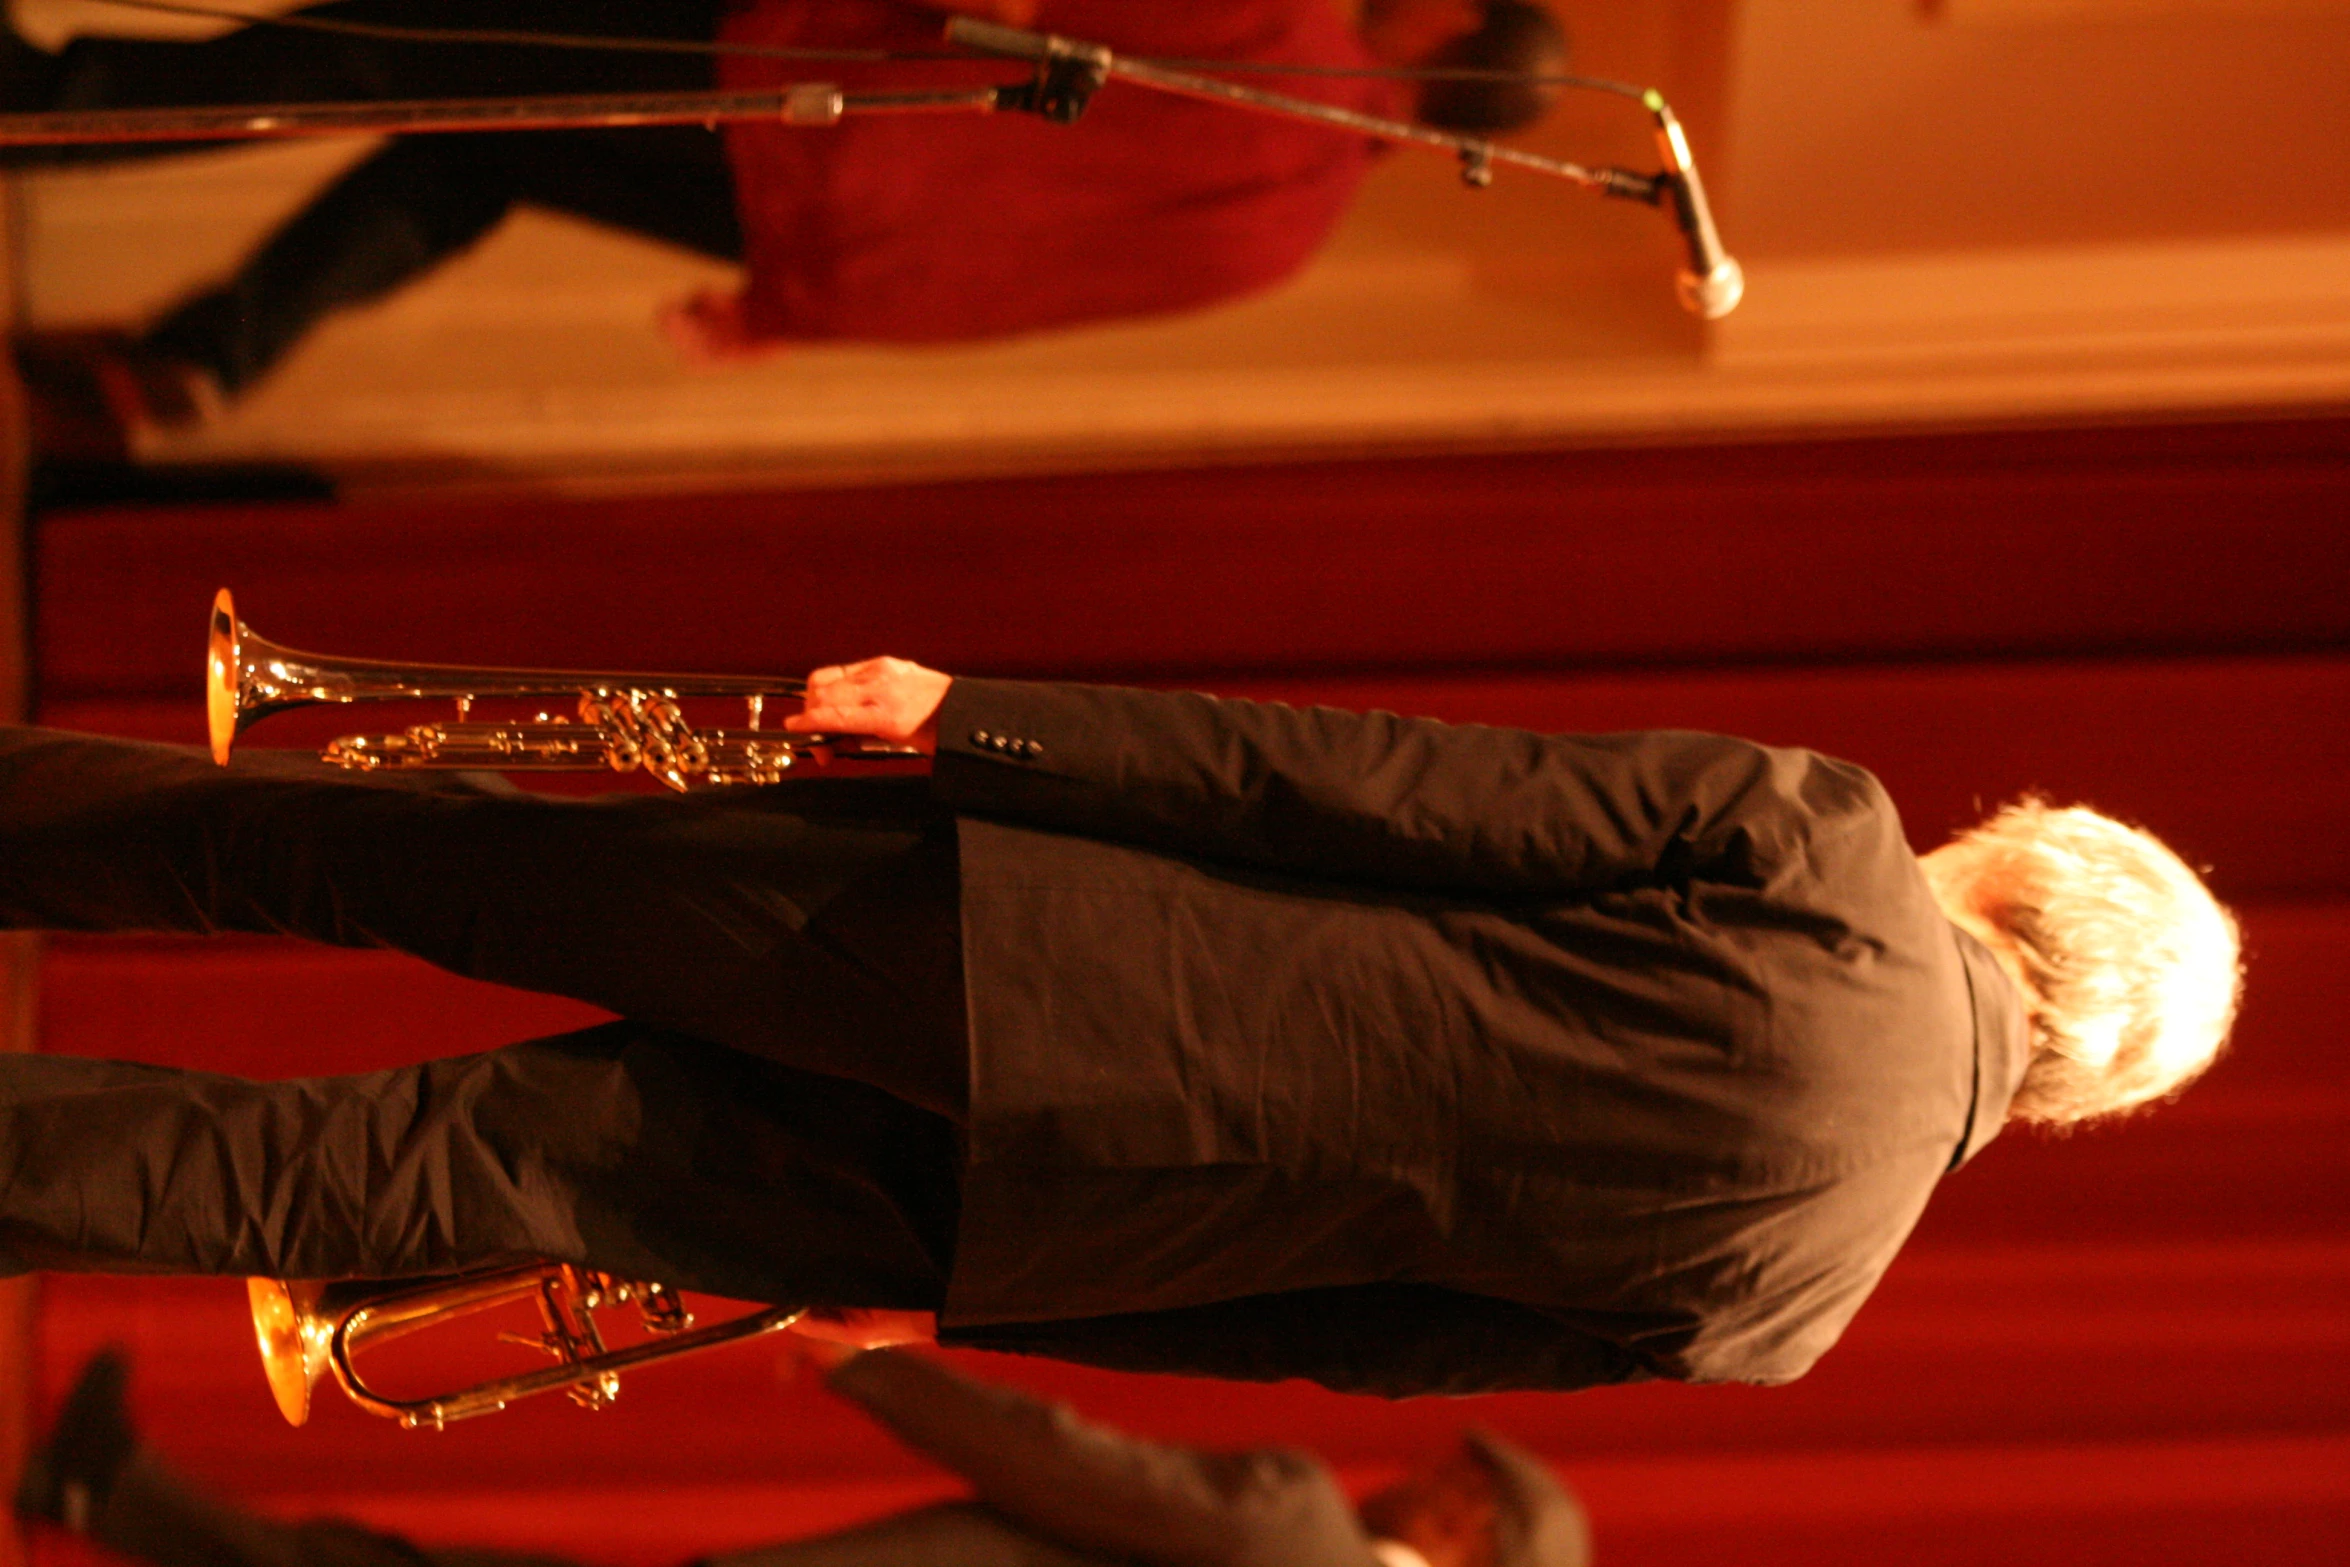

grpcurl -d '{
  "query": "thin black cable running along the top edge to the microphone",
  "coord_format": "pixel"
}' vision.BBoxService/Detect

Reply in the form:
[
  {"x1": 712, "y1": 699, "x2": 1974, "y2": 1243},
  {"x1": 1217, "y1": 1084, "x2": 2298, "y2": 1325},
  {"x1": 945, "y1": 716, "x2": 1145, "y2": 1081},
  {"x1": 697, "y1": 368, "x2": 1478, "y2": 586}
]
[{"x1": 86, "y1": 0, "x2": 1645, "y2": 99}]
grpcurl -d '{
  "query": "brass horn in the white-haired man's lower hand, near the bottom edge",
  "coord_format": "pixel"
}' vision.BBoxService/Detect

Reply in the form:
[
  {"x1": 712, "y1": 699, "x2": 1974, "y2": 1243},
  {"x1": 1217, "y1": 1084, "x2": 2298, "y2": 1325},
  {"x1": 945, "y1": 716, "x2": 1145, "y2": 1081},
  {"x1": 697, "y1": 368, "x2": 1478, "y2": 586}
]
[{"x1": 244, "y1": 1262, "x2": 801, "y2": 1431}]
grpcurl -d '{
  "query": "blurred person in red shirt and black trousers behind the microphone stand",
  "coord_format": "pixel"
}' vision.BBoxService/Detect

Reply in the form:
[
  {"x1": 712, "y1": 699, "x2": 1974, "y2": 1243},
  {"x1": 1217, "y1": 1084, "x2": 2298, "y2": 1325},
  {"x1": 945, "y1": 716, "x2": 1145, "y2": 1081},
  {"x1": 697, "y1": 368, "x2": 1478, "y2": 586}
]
[{"x1": 0, "y1": 0, "x2": 1565, "y2": 444}]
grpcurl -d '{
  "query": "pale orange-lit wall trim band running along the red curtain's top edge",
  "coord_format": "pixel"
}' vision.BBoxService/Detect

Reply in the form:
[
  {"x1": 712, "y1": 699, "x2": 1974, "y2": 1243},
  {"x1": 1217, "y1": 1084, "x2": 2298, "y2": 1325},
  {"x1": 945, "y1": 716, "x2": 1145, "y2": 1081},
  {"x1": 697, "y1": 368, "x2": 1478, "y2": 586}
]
[{"x1": 119, "y1": 233, "x2": 2350, "y2": 486}]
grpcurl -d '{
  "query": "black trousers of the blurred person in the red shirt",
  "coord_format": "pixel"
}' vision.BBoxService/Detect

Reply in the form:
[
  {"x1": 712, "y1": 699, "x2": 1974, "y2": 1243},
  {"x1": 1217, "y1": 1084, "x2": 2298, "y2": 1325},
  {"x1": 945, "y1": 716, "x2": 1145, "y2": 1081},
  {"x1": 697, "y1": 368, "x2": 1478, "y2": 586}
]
[{"x1": 9, "y1": 0, "x2": 743, "y2": 392}]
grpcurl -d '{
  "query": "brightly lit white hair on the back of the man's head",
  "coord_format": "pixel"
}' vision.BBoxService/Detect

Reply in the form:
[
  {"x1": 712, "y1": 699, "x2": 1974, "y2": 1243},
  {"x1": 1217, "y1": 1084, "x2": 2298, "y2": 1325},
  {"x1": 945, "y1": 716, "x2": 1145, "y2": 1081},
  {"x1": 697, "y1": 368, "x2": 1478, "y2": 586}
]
[{"x1": 1922, "y1": 799, "x2": 2244, "y2": 1125}]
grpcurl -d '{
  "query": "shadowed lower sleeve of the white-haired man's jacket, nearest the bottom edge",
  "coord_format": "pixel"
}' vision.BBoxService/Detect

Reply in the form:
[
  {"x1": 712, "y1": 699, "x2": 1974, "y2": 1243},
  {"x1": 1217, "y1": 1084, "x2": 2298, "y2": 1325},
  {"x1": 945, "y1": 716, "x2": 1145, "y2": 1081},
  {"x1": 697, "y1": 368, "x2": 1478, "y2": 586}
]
[{"x1": 945, "y1": 1285, "x2": 1652, "y2": 1398}]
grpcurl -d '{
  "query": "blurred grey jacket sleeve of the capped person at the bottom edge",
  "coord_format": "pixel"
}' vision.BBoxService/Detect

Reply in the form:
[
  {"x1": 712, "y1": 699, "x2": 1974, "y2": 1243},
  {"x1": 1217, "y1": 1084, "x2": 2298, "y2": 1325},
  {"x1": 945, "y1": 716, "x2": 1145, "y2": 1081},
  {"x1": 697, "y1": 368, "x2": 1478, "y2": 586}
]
[{"x1": 827, "y1": 1351, "x2": 1370, "y2": 1567}]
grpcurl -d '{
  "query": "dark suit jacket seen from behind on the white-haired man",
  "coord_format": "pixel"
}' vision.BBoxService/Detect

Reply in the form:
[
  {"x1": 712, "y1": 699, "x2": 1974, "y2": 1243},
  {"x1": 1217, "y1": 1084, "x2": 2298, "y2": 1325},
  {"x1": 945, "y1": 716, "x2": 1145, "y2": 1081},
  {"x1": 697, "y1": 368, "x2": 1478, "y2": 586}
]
[{"x1": 911, "y1": 679, "x2": 2026, "y2": 1393}]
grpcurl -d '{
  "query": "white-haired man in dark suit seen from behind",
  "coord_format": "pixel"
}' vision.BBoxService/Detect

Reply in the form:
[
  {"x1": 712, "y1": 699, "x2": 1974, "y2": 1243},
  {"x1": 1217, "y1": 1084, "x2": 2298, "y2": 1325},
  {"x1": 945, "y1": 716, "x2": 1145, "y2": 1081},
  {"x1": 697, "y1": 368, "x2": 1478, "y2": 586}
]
[{"x1": 0, "y1": 660, "x2": 2237, "y2": 1395}]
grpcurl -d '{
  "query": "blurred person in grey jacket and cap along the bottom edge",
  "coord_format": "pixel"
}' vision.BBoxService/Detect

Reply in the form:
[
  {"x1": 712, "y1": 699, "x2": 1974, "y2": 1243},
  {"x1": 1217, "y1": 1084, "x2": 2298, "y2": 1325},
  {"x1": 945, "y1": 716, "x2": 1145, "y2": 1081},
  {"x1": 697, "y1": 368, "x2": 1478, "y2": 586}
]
[{"x1": 16, "y1": 1351, "x2": 1591, "y2": 1567}]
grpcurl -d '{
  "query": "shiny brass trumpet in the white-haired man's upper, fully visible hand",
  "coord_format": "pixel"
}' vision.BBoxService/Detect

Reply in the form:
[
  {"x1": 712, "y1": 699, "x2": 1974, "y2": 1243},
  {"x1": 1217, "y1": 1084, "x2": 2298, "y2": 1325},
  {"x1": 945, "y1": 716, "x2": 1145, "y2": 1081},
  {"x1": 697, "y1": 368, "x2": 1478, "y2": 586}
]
[{"x1": 204, "y1": 587, "x2": 919, "y2": 789}]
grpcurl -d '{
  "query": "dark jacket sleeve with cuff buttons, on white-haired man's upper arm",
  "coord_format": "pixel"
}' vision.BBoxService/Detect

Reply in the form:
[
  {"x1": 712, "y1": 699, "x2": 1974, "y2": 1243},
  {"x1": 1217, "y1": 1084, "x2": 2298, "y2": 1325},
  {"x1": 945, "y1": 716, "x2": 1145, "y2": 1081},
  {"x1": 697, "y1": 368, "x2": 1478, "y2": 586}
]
[{"x1": 933, "y1": 679, "x2": 1882, "y2": 897}]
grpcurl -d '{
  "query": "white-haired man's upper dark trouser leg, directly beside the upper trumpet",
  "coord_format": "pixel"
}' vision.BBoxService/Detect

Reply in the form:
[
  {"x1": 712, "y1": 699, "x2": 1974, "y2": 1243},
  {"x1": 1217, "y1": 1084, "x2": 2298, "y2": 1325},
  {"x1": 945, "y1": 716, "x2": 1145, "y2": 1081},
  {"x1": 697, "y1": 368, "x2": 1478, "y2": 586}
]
[{"x1": 0, "y1": 728, "x2": 968, "y2": 1116}]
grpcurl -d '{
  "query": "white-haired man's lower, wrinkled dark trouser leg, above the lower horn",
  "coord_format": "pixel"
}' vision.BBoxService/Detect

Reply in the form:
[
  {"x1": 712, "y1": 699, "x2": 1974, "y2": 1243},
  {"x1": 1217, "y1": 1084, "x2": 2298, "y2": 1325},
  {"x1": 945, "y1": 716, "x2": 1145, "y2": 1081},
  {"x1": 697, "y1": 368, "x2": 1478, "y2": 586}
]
[{"x1": 0, "y1": 1022, "x2": 956, "y2": 1311}]
